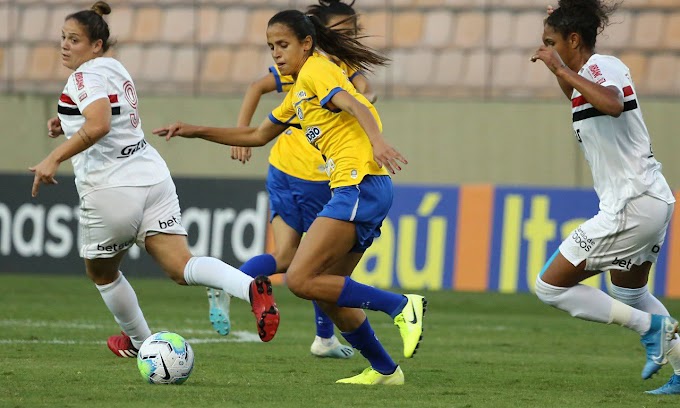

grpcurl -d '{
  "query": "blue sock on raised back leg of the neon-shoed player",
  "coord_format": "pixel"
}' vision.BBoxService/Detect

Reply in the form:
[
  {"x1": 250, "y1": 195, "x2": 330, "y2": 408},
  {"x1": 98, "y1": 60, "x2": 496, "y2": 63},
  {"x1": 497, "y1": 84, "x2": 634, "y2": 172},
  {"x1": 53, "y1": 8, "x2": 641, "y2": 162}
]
[{"x1": 336, "y1": 276, "x2": 408, "y2": 319}]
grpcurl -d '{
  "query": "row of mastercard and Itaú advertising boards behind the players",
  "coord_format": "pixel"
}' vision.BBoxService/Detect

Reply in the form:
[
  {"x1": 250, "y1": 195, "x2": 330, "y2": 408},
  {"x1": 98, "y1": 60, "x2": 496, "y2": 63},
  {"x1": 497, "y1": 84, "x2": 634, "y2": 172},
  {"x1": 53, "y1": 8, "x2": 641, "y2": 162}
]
[{"x1": 0, "y1": 174, "x2": 680, "y2": 297}]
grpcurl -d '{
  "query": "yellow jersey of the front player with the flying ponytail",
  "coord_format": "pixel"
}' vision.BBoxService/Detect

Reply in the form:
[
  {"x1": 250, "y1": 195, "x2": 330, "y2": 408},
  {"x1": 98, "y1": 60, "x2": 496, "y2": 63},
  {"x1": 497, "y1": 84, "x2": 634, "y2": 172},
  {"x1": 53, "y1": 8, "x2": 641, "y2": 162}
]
[{"x1": 269, "y1": 52, "x2": 389, "y2": 188}]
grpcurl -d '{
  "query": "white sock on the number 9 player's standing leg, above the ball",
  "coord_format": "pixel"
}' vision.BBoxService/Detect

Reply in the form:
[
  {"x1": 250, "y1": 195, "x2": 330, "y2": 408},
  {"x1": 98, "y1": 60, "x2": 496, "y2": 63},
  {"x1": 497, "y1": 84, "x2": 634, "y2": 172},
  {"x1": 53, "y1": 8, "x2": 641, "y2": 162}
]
[{"x1": 95, "y1": 271, "x2": 151, "y2": 350}]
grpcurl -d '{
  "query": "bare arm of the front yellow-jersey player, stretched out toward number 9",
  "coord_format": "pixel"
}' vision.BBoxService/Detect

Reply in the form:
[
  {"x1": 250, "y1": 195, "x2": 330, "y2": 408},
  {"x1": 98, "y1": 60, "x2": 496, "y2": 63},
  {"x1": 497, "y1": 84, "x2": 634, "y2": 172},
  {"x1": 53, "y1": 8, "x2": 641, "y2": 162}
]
[{"x1": 153, "y1": 118, "x2": 288, "y2": 147}]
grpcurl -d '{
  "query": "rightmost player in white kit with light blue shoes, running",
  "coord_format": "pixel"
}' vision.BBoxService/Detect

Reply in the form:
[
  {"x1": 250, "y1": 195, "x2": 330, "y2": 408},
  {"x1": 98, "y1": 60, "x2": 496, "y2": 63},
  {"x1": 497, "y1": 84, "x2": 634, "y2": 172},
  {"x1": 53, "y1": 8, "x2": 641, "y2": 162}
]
[{"x1": 531, "y1": 0, "x2": 680, "y2": 394}]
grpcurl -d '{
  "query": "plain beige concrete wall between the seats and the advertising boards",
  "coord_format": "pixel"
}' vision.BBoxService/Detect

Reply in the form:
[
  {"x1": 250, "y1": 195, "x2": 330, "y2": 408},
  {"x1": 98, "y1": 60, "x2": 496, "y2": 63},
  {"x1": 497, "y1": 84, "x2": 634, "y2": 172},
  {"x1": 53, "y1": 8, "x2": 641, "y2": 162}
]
[{"x1": 0, "y1": 95, "x2": 680, "y2": 188}]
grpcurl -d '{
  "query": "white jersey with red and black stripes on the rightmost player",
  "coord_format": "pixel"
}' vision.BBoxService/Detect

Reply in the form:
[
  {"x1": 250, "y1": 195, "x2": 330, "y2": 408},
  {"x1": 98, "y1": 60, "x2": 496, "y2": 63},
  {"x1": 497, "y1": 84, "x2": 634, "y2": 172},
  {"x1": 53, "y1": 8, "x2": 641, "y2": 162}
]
[{"x1": 571, "y1": 54, "x2": 675, "y2": 214}]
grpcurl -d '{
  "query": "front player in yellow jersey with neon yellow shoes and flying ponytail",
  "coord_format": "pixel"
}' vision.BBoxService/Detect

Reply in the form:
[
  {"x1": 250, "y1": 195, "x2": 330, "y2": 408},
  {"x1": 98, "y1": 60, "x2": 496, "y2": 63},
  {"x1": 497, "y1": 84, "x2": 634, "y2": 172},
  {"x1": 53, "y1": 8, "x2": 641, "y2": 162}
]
[{"x1": 154, "y1": 10, "x2": 426, "y2": 385}]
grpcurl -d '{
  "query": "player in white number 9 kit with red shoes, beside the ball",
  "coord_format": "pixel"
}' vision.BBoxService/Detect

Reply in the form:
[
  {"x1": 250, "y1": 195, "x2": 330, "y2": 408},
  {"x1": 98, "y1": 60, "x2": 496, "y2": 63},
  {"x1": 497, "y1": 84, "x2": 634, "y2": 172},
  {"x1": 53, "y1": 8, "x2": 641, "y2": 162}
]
[{"x1": 30, "y1": 1, "x2": 279, "y2": 357}]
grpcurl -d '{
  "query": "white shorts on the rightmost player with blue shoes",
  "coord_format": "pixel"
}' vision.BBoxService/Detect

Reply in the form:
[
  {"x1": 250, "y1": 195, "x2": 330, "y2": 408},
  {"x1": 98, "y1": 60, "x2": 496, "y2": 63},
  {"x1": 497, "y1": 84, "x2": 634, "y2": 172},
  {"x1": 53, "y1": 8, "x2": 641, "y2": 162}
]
[{"x1": 560, "y1": 194, "x2": 674, "y2": 271}]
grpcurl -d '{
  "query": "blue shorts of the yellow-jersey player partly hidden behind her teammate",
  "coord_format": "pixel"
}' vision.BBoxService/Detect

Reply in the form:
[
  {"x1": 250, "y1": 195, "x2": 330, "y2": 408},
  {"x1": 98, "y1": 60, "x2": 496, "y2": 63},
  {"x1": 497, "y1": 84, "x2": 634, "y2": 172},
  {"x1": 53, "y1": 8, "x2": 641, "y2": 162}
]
[{"x1": 266, "y1": 165, "x2": 331, "y2": 235}]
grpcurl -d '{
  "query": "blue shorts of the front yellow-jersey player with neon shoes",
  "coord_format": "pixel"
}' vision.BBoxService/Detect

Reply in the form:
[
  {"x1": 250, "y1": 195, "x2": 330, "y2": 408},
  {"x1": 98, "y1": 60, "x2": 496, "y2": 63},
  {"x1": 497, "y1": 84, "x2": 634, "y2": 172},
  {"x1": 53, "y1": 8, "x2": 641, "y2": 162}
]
[{"x1": 319, "y1": 176, "x2": 393, "y2": 252}]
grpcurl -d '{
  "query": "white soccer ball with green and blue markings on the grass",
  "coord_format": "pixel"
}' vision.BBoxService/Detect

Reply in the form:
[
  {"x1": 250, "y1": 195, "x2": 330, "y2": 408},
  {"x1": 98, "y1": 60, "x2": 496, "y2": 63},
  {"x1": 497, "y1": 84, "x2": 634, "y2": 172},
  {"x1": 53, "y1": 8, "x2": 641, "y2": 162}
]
[{"x1": 137, "y1": 331, "x2": 194, "y2": 384}]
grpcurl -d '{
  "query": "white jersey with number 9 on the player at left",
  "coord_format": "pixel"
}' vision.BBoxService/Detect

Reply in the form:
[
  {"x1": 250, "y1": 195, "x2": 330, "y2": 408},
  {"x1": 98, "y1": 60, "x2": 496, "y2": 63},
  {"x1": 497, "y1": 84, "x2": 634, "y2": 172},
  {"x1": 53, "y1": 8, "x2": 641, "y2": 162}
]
[{"x1": 58, "y1": 57, "x2": 170, "y2": 197}]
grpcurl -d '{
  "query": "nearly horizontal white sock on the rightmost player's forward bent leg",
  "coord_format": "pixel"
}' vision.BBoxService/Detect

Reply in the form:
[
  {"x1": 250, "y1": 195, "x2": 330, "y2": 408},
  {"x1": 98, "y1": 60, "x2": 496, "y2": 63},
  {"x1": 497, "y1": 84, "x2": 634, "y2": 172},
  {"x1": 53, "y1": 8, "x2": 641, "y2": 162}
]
[{"x1": 536, "y1": 277, "x2": 651, "y2": 335}]
